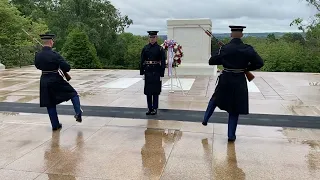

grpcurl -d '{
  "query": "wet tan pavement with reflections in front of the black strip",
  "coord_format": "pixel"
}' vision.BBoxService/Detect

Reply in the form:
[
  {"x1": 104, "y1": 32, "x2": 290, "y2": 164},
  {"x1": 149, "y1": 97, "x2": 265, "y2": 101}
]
[{"x1": 0, "y1": 113, "x2": 320, "y2": 180}]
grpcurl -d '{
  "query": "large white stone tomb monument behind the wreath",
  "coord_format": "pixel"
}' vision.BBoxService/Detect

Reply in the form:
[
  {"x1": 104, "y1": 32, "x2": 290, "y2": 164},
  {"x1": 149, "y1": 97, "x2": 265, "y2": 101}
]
[{"x1": 167, "y1": 18, "x2": 217, "y2": 76}]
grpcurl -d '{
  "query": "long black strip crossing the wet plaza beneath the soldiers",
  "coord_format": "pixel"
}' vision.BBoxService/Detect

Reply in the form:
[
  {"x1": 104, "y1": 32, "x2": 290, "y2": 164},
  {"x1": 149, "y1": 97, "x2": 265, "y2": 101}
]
[{"x1": 0, "y1": 102, "x2": 320, "y2": 129}]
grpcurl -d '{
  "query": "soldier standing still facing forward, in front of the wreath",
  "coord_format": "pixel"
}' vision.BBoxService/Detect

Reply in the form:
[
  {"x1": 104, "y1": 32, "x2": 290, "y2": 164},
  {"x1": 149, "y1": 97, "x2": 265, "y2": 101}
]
[{"x1": 140, "y1": 31, "x2": 166, "y2": 115}]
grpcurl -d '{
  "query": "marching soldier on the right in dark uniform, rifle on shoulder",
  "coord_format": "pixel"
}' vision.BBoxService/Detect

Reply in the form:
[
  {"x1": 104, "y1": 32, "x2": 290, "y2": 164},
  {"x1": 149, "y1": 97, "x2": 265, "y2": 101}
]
[{"x1": 202, "y1": 26, "x2": 264, "y2": 141}]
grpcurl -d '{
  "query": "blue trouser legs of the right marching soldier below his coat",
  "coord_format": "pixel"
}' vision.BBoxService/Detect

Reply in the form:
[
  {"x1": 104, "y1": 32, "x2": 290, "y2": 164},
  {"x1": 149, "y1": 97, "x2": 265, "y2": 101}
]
[{"x1": 203, "y1": 98, "x2": 239, "y2": 139}]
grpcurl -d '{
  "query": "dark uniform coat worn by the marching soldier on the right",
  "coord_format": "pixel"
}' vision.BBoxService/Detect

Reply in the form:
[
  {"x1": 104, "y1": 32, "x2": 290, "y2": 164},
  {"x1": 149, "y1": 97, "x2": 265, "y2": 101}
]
[{"x1": 209, "y1": 38, "x2": 264, "y2": 114}]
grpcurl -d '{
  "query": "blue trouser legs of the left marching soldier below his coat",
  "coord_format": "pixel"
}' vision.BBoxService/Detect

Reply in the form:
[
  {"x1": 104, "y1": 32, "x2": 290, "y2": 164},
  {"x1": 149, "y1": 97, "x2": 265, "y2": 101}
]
[{"x1": 47, "y1": 95, "x2": 82, "y2": 128}]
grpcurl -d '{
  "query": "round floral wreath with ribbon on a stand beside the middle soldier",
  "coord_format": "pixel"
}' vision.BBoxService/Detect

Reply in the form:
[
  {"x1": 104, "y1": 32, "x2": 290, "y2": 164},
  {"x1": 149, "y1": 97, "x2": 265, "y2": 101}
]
[{"x1": 160, "y1": 39, "x2": 183, "y2": 67}]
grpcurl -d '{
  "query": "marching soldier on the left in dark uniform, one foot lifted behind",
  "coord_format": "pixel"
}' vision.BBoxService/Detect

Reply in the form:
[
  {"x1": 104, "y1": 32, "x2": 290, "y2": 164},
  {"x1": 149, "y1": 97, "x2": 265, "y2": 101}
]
[{"x1": 34, "y1": 34, "x2": 82, "y2": 131}]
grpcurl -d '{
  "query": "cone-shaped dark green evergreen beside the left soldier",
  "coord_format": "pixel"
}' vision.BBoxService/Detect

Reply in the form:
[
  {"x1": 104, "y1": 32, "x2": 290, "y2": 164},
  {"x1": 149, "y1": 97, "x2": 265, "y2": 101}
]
[{"x1": 62, "y1": 29, "x2": 101, "y2": 69}]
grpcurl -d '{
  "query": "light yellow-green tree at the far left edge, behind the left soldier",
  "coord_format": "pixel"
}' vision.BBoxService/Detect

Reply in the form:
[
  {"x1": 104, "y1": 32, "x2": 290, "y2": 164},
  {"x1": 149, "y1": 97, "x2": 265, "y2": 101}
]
[{"x1": 0, "y1": 0, "x2": 47, "y2": 67}]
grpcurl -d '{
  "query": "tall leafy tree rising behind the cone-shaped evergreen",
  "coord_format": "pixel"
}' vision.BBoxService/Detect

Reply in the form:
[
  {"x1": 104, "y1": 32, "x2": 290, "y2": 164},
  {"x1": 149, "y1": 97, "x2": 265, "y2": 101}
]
[{"x1": 12, "y1": 0, "x2": 133, "y2": 63}]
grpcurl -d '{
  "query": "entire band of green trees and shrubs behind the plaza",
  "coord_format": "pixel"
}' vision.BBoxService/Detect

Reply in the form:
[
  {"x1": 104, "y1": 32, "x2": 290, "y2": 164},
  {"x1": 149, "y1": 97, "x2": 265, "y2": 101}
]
[{"x1": 0, "y1": 0, "x2": 320, "y2": 72}]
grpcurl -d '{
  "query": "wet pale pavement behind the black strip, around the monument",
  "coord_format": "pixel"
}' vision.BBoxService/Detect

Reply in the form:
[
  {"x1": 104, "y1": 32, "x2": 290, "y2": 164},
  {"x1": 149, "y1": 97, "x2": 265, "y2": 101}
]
[{"x1": 0, "y1": 67, "x2": 320, "y2": 116}]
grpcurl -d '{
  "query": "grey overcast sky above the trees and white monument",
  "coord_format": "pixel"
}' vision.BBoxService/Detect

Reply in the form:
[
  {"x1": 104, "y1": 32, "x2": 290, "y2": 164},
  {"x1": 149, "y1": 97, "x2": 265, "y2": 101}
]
[{"x1": 110, "y1": 0, "x2": 316, "y2": 35}]
